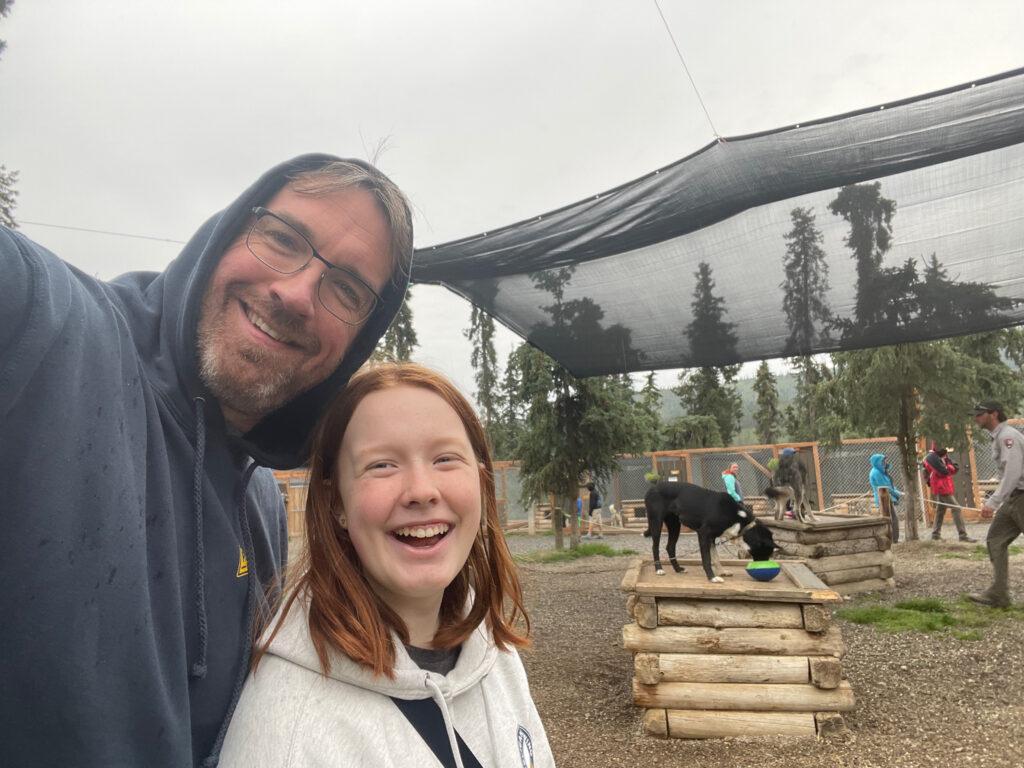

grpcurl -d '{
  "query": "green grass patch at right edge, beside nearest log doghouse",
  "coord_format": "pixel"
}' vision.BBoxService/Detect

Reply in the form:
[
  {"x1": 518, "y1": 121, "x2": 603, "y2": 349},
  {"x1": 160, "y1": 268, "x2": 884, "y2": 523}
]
[{"x1": 836, "y1": 597, "x2": 1024, "y2": 640}]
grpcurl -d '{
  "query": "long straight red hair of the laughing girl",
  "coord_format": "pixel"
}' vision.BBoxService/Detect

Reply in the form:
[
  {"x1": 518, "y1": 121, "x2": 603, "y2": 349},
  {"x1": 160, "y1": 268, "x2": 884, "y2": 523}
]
[{"x1": 253, "y1": 362, "x2": 529, "y2": 677}]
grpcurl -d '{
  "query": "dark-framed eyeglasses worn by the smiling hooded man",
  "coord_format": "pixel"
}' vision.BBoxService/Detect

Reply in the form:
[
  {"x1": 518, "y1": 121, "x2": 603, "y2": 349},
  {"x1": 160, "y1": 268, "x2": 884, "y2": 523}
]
[{"x1": 246, "y1": 206, "x2": 381, "y2": 326}]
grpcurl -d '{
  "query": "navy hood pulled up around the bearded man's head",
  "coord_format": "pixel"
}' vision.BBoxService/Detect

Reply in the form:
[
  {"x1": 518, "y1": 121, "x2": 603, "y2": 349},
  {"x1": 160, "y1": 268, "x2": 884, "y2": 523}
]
[{"x1": 104, "y1": 155, "x2": 409, "y2": 469}]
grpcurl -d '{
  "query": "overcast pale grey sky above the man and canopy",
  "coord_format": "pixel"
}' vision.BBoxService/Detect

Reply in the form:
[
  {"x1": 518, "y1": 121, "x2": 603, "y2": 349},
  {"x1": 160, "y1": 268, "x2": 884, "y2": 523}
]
[{"x1": 0, "y1": 0, "x2": 1024, "y2": 403}]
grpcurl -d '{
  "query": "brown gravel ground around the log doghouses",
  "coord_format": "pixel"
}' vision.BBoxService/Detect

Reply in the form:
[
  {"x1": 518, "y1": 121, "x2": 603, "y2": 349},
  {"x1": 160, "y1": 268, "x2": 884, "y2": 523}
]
[{"x1": 509, "y1": 523, "x2": 1024, "y2": 768}]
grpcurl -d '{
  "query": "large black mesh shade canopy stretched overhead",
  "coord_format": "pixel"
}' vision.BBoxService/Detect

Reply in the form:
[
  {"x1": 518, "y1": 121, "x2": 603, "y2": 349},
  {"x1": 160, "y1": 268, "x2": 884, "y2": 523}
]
[{"x1": 413, "y1": 70, "x2": 1024, "y2": 376}]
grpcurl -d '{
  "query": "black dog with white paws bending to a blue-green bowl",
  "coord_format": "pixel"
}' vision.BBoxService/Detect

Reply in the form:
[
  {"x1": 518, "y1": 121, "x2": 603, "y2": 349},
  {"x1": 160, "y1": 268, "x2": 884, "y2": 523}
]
[{"x1": 643, "y1": 482, "x2": 775, "y2": 582}]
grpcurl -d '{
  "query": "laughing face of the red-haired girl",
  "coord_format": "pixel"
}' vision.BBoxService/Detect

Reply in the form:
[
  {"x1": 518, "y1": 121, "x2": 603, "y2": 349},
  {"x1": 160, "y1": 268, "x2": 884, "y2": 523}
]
[{"x1": 336, "y1": 384, "x2": 481, "y2": 638}]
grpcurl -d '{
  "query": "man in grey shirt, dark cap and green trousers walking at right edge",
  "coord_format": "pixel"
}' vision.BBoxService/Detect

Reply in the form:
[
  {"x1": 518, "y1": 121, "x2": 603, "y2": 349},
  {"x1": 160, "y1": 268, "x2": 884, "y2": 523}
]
[{"x1": 968, "y1": 400, "x2": 1024, "y2": 608}]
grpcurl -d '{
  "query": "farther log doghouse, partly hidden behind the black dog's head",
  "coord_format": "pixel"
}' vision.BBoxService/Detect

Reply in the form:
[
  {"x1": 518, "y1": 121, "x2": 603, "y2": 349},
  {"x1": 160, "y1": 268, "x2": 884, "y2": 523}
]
[{"x1": 762, "y1": 515, "x2": 896, "y2": 595}]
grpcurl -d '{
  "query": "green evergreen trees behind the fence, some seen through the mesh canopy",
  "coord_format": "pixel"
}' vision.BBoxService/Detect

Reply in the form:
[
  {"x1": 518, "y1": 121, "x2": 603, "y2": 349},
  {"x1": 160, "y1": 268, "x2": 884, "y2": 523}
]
[{"x1": 382, "y1": 182, "x2": 1024, "y2": 547}]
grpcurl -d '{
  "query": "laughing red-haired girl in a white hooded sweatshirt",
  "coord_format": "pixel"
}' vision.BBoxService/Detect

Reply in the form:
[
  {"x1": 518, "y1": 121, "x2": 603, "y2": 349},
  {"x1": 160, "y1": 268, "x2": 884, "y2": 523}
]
[{"x1": 220, "y1": 364, "x2": 554, "y2": 768}]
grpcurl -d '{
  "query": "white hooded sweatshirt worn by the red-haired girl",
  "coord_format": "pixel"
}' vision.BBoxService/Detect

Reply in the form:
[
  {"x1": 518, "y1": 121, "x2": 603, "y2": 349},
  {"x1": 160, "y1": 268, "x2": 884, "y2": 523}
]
[{"x1": 220, "y1": 601, "x2": 555, "y2": 768}]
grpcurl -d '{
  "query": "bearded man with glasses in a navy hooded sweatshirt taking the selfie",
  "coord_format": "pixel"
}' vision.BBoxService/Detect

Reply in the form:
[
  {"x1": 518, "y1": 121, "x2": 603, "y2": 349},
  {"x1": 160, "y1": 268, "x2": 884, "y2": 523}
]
[{"x1": 0, "y1": 155, "x2": 413, "y2": 768}]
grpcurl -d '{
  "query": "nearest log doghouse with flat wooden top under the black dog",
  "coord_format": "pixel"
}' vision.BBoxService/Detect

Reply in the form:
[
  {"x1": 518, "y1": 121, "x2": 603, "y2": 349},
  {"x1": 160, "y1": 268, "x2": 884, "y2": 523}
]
[{"x1": 623, "y1": 560, "x2": 854, "y2": 738}]
